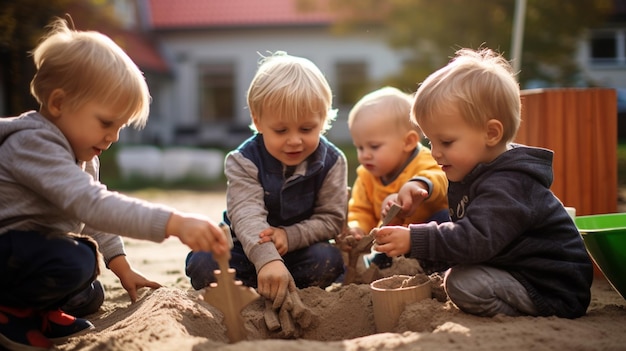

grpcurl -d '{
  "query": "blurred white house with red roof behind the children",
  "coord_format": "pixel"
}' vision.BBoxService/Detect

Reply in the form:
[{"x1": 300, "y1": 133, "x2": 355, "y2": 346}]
[{"x1": 116, "y1": 0, "x2": 400, "y2": 147}]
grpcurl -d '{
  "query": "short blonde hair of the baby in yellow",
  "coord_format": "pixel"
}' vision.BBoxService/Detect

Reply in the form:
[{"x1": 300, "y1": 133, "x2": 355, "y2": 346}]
[{"x1": 348, "y1": 86, "x2": 421, "y2": 133}]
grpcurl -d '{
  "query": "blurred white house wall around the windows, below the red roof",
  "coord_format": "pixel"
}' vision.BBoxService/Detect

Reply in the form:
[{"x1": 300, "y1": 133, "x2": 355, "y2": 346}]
[{"x1": 155, "y1": 28, "x2": 401, "y2": 146}]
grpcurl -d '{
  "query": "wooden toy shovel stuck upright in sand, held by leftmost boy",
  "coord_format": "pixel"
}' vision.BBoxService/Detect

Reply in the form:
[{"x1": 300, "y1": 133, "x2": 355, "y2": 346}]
[{"x1": 204, "y1": 225, "x2": 259, "y2": 343}]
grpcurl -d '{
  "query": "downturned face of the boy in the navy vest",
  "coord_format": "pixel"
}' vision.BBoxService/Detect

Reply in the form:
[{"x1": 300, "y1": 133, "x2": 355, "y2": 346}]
[{"x1": 253, "y1": 111, "x2": 323, "y2": 166}]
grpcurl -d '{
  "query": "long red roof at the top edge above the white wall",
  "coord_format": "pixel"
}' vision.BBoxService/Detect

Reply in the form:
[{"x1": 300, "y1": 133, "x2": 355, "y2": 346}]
[{"x1": 150, "y1": 0, "x2": 333, "y2": 29}]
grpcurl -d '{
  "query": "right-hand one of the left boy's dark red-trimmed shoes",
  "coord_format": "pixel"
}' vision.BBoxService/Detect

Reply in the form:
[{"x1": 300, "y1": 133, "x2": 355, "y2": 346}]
[{"x1": 42, "y1": 310, "x2": 94, "y2": 343}]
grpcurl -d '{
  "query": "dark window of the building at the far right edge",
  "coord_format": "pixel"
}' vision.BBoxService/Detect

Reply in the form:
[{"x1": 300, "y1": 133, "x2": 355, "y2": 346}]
[{"x1": 590, "y1": 29, "x2": 626, "y2": 65}]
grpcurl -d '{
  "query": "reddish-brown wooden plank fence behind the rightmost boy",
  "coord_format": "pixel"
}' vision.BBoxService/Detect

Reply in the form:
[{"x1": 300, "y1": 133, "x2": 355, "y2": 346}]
[{"x1": 515, "y1": 88, "x2": 617, "y2": 216}]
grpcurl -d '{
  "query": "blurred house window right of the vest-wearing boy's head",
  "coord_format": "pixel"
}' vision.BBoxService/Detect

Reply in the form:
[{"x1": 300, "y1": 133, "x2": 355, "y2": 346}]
[{"x1": 335, "y1": 61, "x2": 368, "y2": 106}]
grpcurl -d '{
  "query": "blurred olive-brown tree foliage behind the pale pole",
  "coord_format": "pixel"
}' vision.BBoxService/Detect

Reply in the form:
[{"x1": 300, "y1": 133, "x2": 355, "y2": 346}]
[{"x1": 299, "y1": 0, "x2": 613, "y2": 90}]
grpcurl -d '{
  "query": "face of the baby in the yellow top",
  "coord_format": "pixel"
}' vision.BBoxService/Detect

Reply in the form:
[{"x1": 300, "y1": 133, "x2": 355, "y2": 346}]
[{"x1": 350, "y1": 111, "x2": 410, "y2": 180}]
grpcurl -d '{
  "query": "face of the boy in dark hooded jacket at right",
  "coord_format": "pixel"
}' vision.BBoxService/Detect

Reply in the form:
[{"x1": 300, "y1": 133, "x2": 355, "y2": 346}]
[{"x1": 420, "y1": 107, "x2": 492, "y2": 182}]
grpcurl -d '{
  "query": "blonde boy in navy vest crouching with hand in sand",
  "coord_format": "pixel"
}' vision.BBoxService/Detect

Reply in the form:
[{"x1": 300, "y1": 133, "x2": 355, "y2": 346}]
[{"x1": 186, "y1": 52, "x2": 348, "y2": 305}]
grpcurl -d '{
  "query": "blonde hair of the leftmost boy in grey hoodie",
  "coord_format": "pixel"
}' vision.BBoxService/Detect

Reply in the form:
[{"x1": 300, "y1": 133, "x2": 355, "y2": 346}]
[{"x1": 30, "y1": 18, "x2": 150, "y2": 128}]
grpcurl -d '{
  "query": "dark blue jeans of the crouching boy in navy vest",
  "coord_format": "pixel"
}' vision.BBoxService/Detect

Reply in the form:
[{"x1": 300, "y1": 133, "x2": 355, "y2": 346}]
[{"x1": 185, "y1": 241, "x2": 344, "y2": 290}]
